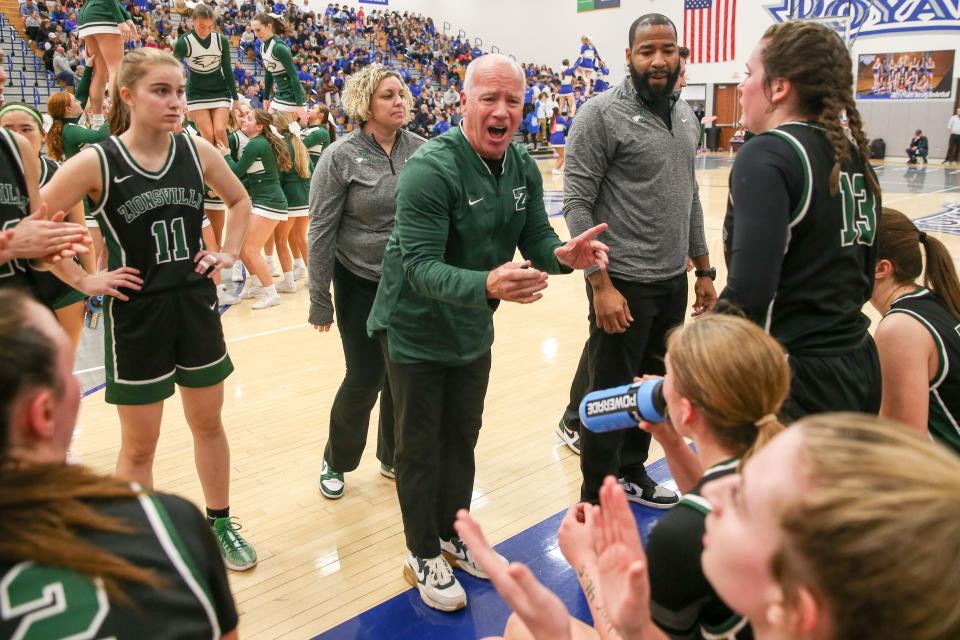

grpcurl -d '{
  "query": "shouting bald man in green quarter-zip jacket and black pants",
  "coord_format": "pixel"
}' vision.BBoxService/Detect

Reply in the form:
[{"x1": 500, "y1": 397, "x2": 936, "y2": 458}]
[{"x1": 367, "y1": 55, "x2": 607, "y2": 611}]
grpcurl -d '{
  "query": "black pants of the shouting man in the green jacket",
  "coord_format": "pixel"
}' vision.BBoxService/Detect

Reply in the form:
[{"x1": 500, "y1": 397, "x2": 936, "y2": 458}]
[{"x1": 381, "y1": 334, "x2": 490, "y2": 558}]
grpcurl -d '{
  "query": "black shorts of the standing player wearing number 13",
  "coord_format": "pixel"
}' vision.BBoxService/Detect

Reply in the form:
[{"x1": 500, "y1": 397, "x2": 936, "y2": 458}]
[{"x1": 781, "y1": 334, "x2": 883, "y2": 420}]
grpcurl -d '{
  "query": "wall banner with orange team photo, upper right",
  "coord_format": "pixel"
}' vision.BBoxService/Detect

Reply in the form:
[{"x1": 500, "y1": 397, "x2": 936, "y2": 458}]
[{"x1": 857, "y1": 51, "x2": 954, "y2": 100}]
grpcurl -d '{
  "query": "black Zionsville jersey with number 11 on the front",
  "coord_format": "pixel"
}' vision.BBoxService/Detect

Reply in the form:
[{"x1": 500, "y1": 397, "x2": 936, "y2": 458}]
[{"x1": 92, "y1": 133, "x2": 205, "y2": 298}]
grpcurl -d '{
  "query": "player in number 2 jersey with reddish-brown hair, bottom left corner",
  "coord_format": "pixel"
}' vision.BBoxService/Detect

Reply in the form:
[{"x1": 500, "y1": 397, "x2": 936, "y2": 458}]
[{"x1": 0, "y1": 290, "x2": 237, "y2": 640}]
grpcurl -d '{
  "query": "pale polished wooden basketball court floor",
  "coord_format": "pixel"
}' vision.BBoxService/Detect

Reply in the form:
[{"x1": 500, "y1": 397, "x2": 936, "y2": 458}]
[{"x1": 72, "y1": 154, "x2": 960, "y2": 639}]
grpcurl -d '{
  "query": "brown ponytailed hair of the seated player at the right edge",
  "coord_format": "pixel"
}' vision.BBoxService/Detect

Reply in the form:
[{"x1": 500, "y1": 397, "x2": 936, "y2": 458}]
[{"x1": 877, "y1": 207, "x2": 960, "y2": 319}]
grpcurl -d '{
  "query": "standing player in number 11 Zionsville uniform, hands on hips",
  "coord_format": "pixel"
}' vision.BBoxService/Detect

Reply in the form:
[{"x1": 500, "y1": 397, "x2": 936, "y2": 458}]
[{"x1": 41, "y1": 48, "x2": 256, "y2": 569}]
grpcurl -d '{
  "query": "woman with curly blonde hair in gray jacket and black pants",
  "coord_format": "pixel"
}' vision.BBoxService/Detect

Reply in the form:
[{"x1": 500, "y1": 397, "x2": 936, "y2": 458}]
[{"x1": 309, "y1": 65, "x2": 425, "y2": 499}]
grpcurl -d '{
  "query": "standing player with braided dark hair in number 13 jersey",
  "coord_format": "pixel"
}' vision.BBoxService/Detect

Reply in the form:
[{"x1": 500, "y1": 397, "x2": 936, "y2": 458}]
[{"x1": 720, "y1": 22, "x2": 881, "y2": 418}]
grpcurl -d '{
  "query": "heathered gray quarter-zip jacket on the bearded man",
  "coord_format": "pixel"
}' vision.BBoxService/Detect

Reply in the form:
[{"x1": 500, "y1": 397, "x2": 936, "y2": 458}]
[{"x1": 563, "y1": 78, "x2": 708, "y2": 282}]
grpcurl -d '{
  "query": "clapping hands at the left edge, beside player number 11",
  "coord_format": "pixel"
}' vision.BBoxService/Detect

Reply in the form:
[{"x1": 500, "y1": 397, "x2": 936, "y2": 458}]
[{"x1": 7, "y1": 206, "x2": 93, "y2": 264}]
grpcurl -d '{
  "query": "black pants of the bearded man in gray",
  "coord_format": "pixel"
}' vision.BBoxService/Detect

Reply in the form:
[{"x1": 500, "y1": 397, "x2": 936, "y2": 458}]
[{"x1": 564, "y1": 273, "x2": 687, "y2": 504}]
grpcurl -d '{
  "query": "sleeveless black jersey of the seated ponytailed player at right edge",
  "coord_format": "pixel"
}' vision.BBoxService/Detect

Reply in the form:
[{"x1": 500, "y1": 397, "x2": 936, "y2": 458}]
[{"x1": 884, "y1": 287, "x2": 960, "y2": 453}]
